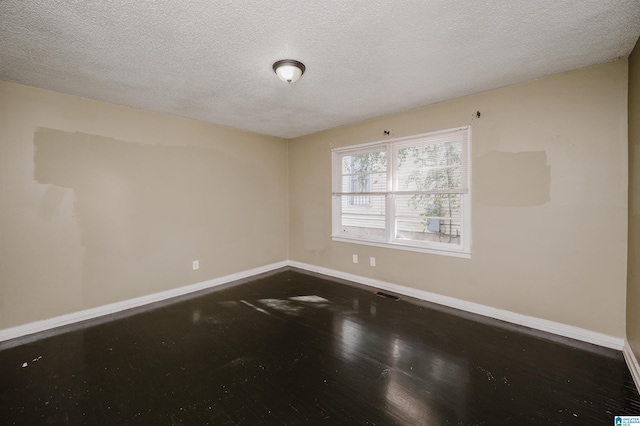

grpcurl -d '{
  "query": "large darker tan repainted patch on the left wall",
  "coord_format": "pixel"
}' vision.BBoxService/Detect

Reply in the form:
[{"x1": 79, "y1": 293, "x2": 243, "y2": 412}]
[{"x1": 34, "y1": 128, "x2": 278, "y2": 307}]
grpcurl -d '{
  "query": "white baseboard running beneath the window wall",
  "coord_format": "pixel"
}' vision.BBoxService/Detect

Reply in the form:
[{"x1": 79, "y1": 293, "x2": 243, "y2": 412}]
[{"x1": 289, "y1": 261, "x2": 624, "y2": 350}]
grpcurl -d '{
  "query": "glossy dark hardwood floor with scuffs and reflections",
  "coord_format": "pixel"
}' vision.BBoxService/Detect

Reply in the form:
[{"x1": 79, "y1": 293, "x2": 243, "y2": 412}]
[{"x1": 0, "y1": 270, "x2": 640, "y2": 425}]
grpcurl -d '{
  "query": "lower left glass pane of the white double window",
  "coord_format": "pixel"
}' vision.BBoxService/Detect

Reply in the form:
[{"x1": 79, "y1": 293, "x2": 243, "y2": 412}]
[{"x1": 340, "y1": 195, "x2": 385, "y2": 240}]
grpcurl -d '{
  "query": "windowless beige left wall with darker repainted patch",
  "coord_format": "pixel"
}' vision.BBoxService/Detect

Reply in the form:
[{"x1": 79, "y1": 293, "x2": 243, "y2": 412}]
[{"x1": 0, "y1": 82, "x2": 288, "y2": 329}]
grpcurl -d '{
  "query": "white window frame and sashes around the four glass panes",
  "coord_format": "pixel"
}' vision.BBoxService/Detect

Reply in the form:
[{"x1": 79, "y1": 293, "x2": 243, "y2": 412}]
[{"x1": 331, "y1": 126, "x2": 471, "y2": 258}]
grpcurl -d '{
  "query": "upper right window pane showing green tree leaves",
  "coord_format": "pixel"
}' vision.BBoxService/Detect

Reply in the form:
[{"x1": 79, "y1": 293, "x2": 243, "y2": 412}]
[{"x1": 396, "y1": 142, "x2": 462, "y2": 191}]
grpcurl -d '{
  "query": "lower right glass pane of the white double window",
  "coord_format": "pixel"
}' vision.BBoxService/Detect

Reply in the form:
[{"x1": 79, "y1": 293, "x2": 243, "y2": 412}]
[{"x1": 396, "y1": 194, "x2": 462, "y2": 245}]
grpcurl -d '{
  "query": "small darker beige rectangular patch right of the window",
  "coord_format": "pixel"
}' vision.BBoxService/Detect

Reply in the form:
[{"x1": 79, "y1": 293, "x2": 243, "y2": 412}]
[{"x1": 473, "y1": 151, "x2": 551, "y2": 207}]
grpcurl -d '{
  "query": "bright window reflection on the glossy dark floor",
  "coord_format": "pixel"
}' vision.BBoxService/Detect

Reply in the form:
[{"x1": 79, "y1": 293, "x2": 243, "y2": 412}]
[{"x1": 333, "y1": 299, "x2": 469, "y2": 425}]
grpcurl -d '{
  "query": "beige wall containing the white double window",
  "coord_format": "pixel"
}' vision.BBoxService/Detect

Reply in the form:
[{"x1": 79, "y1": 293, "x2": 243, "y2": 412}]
[{"x1": 289, "y1": 60, "x2": 628, "y2": 337}]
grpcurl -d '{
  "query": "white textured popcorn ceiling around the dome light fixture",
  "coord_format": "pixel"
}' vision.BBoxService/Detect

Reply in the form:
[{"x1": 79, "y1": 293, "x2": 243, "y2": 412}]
[{"x1": 0, "y1": 0, "x2": 640, "y2": 138}]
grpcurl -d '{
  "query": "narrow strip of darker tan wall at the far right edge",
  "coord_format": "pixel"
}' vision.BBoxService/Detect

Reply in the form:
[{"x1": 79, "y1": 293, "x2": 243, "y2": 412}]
[{"x1": 627, "y1": 43, "x2": 640, "y2": 359}]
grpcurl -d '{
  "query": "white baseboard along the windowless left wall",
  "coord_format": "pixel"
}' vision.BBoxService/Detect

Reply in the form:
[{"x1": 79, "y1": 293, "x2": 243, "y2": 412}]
[{"x1": 0, "y1": 261, "x2": 289, "y2": 342}]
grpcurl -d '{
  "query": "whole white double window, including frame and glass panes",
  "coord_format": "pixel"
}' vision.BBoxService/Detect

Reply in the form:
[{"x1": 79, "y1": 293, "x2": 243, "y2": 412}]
[{"x1": 332, "y1": 127, "x2": 471, "y2": 257}]
